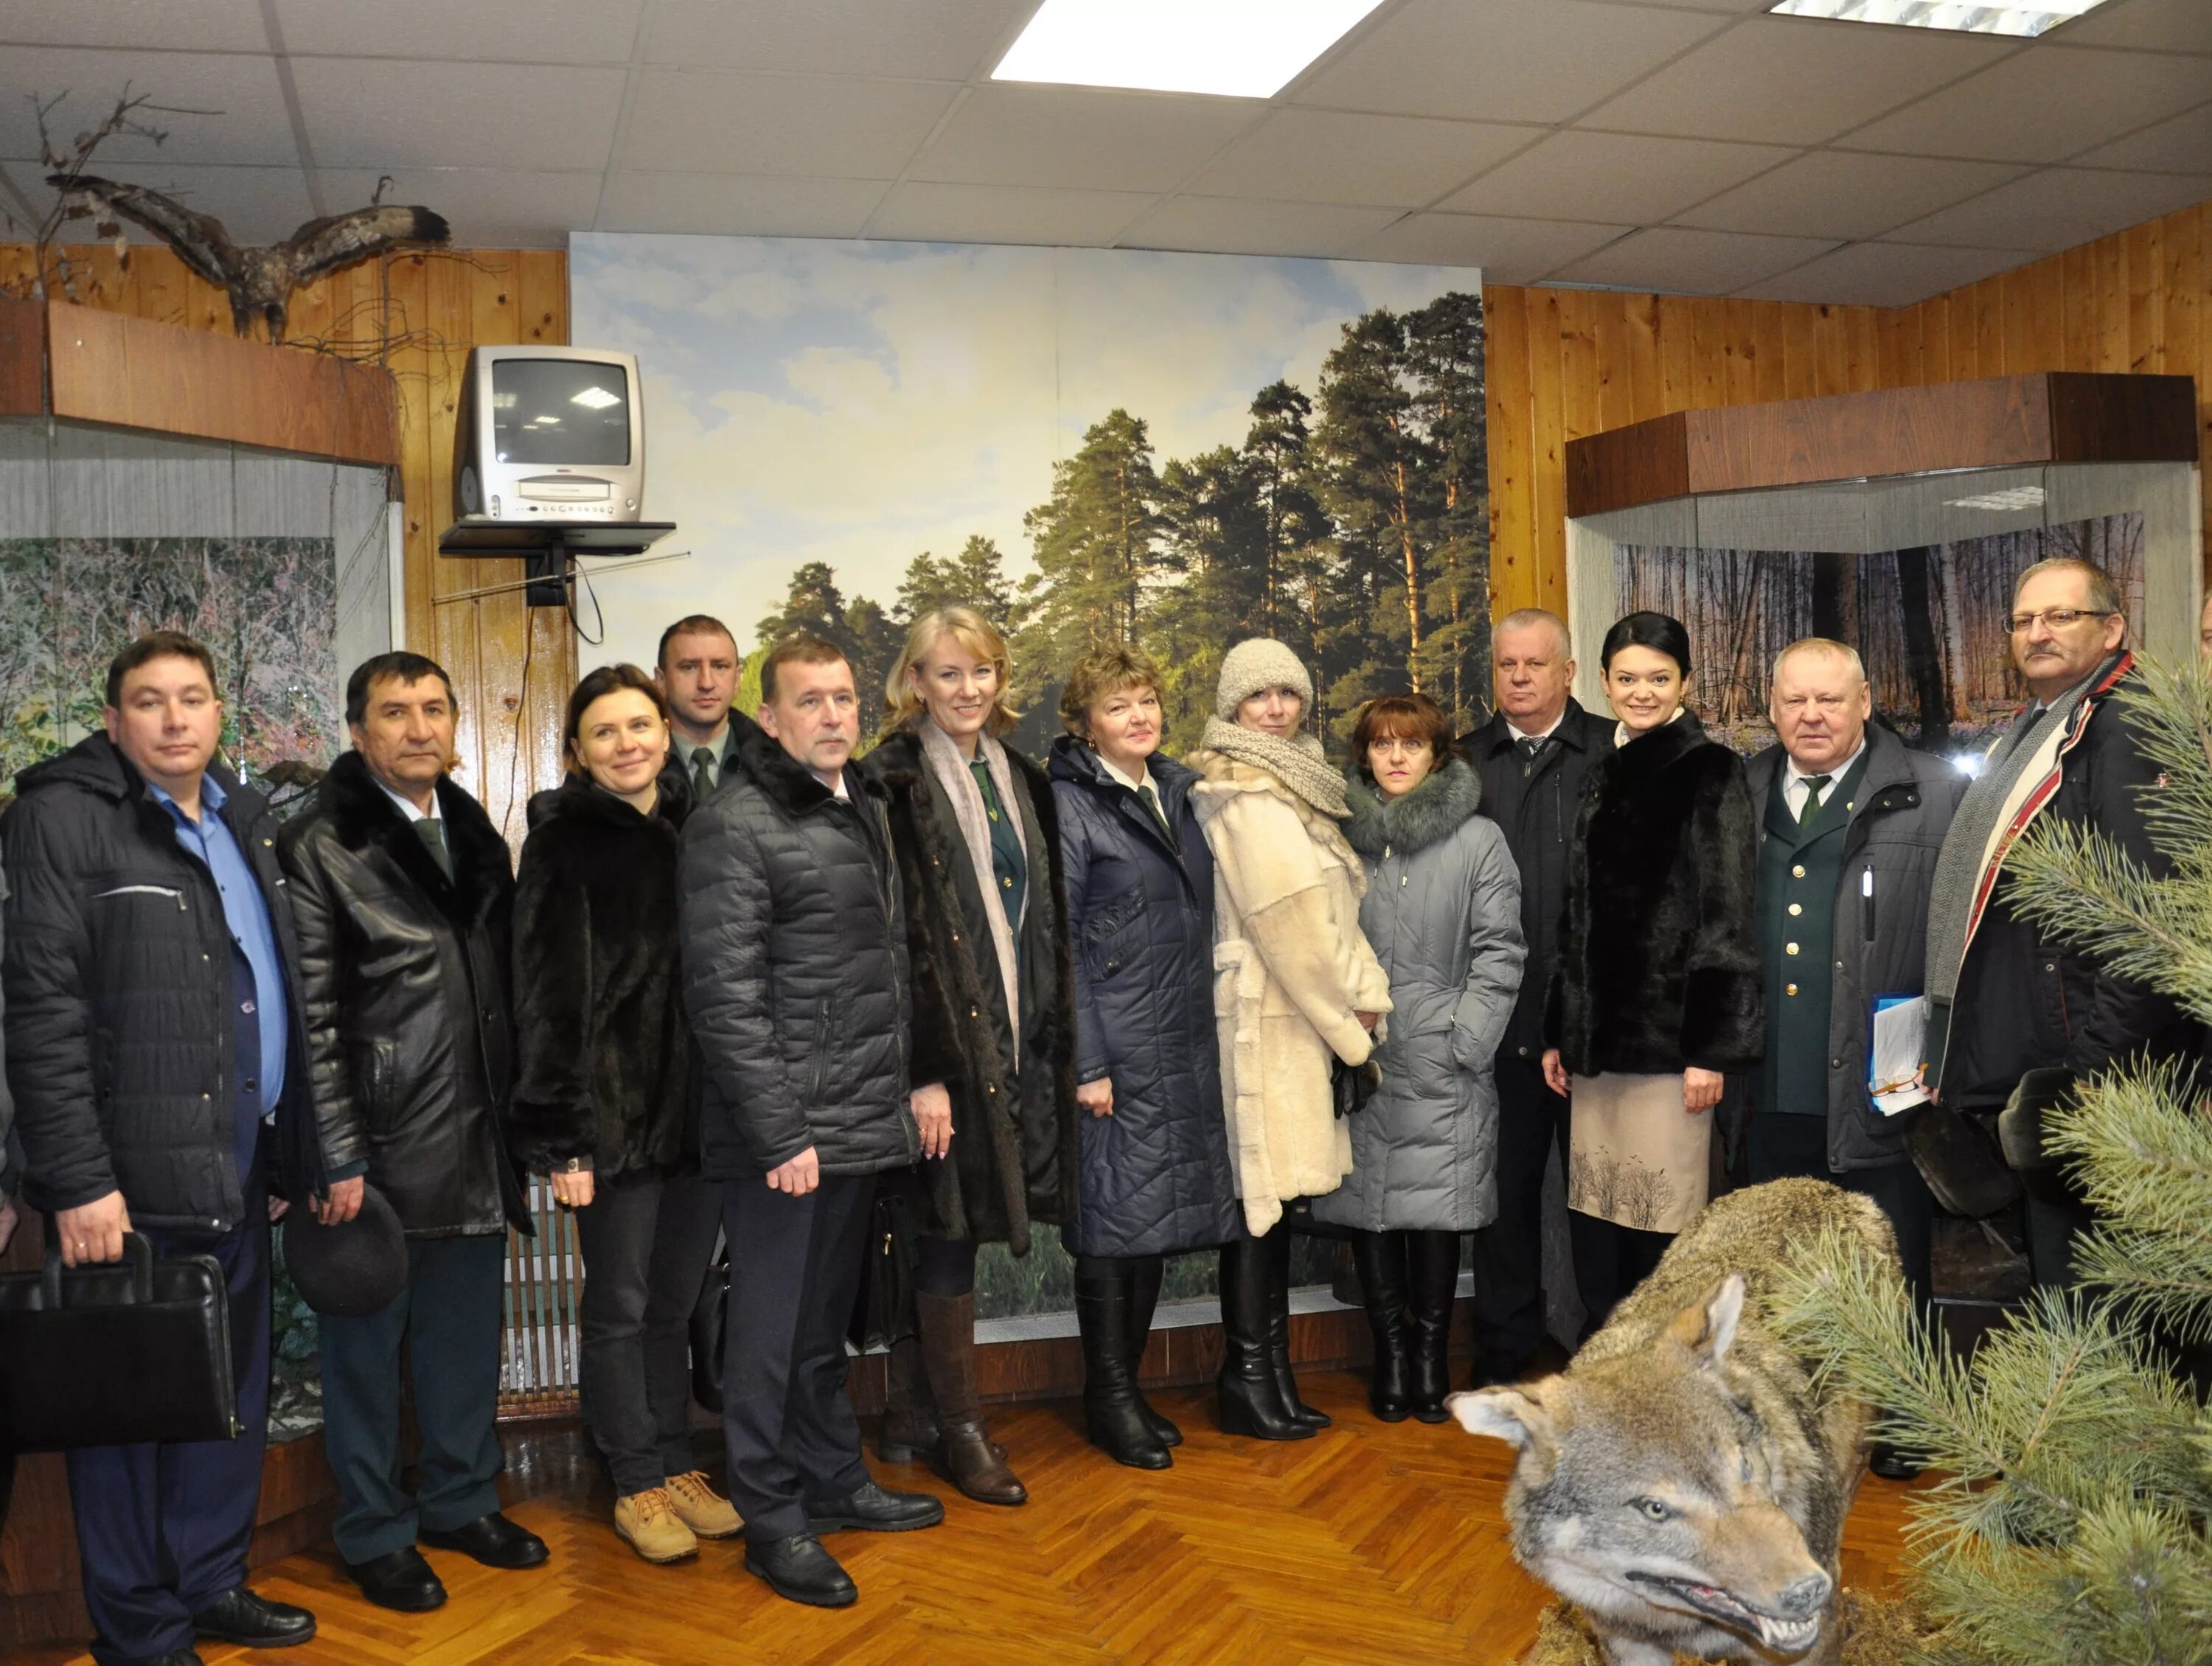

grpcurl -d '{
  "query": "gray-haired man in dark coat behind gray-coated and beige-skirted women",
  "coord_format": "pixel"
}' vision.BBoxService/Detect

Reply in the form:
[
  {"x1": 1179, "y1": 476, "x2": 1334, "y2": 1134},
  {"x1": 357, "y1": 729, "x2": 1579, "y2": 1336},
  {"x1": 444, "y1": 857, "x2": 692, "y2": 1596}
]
[{"x1": 1460, "y1": 608, "x2": 1613, "y2": 1387}]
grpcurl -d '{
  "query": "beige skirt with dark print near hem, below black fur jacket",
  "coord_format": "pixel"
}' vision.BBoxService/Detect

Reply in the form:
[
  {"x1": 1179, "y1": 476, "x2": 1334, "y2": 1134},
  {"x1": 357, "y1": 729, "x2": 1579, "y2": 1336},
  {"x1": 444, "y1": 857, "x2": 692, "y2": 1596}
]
[{"x1": 1566, "y1": 1071, "x2": 1712, "y2": 1233}]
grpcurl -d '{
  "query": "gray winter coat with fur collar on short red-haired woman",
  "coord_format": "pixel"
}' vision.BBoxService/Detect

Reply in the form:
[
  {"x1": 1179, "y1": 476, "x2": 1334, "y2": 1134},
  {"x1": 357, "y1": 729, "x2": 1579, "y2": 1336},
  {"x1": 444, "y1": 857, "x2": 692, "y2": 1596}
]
[{"x1": 1314, "y1": 759, "x2": 1526, "y2": 1233}]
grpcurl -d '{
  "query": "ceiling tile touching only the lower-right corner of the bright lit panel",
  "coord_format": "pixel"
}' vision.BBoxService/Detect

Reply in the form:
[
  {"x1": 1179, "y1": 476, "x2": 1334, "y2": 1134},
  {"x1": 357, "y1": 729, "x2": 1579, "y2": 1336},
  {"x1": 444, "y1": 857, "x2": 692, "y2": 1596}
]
[{"x1": 1192, "y1": 111, "x2": 1537, "y2": 208}]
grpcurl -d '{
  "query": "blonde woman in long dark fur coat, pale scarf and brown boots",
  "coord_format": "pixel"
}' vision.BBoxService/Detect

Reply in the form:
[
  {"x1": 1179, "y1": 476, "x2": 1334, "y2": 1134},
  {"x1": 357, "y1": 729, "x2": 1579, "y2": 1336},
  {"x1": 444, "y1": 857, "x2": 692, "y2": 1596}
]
[{"x1": 860, "y1": 608, "x2": 1075, "y2": 1505}]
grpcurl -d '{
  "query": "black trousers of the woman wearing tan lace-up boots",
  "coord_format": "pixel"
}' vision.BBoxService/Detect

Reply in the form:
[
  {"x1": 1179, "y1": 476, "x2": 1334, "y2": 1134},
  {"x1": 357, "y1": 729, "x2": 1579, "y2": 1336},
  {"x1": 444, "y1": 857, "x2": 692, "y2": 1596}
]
[{"x1": 575, "y1": 1175, "x2": 721, "y2": 1498}]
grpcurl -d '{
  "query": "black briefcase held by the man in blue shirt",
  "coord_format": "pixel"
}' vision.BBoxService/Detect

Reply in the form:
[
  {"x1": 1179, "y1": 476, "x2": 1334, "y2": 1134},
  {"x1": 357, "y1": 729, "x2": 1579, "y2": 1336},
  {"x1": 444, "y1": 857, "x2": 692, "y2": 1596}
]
[{"x1": 0, "y1": 1233, "x2": 239, "y2": 1451}]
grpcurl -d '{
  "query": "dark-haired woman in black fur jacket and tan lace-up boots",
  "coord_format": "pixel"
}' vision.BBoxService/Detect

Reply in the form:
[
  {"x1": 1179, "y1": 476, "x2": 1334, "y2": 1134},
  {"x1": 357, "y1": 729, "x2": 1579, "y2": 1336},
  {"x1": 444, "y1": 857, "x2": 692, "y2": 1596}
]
[{"x1": 509, "y1": 666, "x2": 741, "y2": 1562}]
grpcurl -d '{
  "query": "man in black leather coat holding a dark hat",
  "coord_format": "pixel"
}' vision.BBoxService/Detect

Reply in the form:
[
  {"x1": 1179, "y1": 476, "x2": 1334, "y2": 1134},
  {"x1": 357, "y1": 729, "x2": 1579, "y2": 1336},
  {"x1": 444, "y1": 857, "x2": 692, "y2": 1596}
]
[{"x1": 279, "y1": 652, "x2": 546, "y2": 1613}]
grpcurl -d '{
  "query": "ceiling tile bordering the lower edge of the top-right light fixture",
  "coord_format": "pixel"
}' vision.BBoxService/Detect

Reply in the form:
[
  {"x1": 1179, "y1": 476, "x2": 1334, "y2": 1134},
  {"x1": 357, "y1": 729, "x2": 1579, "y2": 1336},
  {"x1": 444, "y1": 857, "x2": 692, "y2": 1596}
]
[{"x1": 1584, "y1": 18, "x2": 2006, "y2": 144}]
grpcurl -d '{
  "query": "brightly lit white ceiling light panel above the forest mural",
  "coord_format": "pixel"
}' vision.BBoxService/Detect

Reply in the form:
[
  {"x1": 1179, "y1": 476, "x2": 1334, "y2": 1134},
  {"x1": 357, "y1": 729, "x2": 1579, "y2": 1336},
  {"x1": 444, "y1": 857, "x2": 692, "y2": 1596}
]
[{"x1": 991, "y1": 0, "x2": 1382, "y2": 97}]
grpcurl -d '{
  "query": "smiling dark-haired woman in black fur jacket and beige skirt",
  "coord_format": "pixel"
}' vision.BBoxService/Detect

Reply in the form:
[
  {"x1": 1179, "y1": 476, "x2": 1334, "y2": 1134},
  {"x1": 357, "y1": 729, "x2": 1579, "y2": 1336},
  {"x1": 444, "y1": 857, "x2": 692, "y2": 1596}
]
[{"x1": 1544, "y1": 613, "x2": 1765, "y2": 1336}]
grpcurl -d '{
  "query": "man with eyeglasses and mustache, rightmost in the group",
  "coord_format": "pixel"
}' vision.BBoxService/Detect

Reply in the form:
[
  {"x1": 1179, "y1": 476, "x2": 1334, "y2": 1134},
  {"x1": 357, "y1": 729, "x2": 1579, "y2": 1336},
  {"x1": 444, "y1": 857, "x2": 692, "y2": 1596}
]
[{"x1": 1924, "y1": 557, "x2": 2197, "y2": 1288}]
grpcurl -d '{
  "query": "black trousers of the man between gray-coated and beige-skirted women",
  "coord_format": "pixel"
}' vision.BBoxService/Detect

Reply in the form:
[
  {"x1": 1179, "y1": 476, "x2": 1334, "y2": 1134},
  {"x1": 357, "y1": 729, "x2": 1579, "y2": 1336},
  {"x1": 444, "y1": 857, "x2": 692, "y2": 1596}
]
[{"x1": 1473, "y1": 1053, "x2": 1568, "y2": 1374}]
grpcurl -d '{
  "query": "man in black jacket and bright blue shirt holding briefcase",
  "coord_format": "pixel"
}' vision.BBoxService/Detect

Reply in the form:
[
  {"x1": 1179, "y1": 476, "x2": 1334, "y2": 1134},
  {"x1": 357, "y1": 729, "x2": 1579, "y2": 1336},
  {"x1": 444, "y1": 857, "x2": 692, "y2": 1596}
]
[{"x1": 0, "y1": 630, "x2": 321, "y2": 1666}]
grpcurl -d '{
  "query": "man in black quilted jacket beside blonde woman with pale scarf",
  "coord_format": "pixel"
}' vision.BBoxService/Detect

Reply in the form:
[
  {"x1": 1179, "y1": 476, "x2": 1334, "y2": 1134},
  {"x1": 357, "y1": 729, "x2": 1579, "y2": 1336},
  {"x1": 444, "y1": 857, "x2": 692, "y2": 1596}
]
[{"x1": 677, "y1": 635, "x2": 945, "y2": 1609}]
